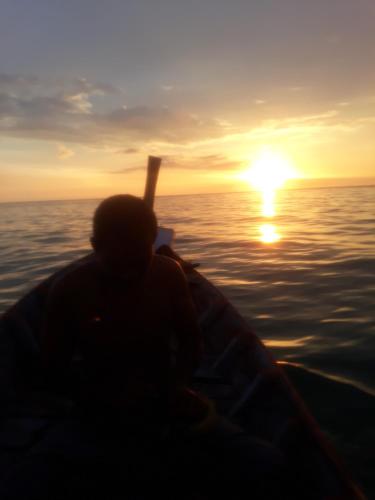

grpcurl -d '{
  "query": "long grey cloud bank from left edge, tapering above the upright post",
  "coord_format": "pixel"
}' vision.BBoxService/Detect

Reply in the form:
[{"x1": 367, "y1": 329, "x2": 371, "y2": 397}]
[{"x1": 0, "y1": 75, "x2": 232, "y2": 145}]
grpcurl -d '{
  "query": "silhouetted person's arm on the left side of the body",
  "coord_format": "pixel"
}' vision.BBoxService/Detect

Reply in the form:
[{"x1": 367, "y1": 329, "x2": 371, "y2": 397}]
[{"x1": 41, "y1": 279, "x2": 76, "y2": 390}]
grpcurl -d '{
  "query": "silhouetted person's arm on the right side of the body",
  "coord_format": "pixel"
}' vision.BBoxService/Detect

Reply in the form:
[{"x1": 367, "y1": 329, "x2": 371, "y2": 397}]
[{"x1": 171, "y1": 263, "x2": 203, "y2": 386}]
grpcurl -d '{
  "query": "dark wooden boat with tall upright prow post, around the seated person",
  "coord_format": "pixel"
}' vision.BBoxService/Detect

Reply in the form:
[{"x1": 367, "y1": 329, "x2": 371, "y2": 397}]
[{"x1": 0, "y1": 157, "x2": 365, "y2": 500}]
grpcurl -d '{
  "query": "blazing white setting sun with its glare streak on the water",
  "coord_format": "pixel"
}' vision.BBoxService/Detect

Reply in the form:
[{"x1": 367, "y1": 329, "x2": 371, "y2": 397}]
[{"x1": 242, "y1": 149, "x2": 296, "y2": 243}]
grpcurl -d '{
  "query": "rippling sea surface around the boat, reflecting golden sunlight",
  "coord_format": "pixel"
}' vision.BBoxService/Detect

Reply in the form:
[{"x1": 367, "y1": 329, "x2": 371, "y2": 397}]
[{"x1": 0, "y1": 186, "x2": 375, "y2": 492}]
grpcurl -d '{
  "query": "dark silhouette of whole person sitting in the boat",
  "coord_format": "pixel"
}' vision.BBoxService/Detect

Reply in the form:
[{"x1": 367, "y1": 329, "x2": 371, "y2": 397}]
[{"x1": 42, "y1": 195, "x2": 201, "y2": 419}]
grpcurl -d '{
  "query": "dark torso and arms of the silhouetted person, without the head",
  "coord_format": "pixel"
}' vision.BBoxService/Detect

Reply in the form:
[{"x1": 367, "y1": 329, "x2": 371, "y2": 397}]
[{"x1": 43, "y1": 255, "x2": 200, "y2": 410}]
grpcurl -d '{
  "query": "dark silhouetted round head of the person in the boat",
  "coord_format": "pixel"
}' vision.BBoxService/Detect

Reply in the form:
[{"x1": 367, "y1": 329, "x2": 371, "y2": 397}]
[{"x1": 91, "y1": 194, "x2": 157, "y2": 279}]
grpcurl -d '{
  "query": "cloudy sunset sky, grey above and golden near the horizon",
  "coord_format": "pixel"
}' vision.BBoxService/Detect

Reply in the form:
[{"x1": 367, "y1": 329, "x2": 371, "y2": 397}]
[{"x1": 0, "y1": 0, "x2": 375, "y2": 202}]
